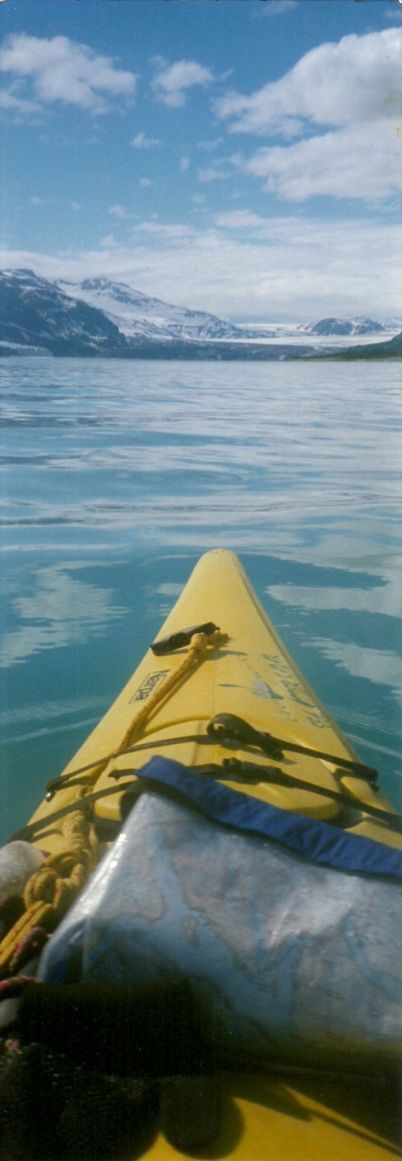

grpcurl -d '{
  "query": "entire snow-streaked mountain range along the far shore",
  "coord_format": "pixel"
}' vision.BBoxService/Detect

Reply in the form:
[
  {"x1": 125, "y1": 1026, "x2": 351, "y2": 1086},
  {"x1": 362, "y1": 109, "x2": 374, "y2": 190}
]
[{"x1": 0, "y1": 268, "x2": 399, "y2": 361}]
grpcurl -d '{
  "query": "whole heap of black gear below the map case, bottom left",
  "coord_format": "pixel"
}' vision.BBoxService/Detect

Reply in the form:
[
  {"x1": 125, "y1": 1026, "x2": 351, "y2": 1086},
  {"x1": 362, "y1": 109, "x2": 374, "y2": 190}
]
[{"x1": 0, "y1": 981, "x2": 220, "y2": 1161}]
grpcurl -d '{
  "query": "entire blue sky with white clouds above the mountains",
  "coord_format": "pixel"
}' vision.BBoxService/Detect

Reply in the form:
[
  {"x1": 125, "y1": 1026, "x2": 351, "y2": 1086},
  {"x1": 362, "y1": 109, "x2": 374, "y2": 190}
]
[{"x1": 0, "y1": 0, "x2": 402, "y2": 322}]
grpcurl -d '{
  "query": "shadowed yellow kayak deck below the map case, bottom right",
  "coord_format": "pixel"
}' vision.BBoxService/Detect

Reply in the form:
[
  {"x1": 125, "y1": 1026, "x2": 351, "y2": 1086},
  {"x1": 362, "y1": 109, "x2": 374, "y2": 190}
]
[{"x1": 142, "y1": 1073, "x2": 400, "y2": 1161}]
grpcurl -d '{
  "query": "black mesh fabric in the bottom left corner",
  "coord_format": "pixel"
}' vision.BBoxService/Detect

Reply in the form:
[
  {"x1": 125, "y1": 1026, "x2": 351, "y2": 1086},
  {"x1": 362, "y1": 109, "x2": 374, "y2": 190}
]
[{"x1": 0, "y1": 1044, "x2": 159, "y2": 1161}]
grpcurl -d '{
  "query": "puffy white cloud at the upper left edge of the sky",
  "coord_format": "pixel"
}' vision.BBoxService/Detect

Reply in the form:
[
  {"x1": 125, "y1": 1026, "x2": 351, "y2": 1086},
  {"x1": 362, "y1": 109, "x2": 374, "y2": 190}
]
[{"x1": 0, "y1": 33, "x2": 137, "y2": 114}]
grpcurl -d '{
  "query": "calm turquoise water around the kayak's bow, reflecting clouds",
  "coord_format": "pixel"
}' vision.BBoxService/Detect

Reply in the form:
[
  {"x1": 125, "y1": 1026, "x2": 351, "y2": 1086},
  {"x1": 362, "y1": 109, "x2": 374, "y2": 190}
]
[{"x1": 0, "y1": 359, "x2": 401, "y2": 841}]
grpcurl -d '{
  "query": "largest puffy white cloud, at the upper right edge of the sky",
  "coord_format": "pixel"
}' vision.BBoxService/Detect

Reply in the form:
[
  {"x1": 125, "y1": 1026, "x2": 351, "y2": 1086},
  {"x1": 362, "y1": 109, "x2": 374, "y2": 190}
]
[{"x1": 215, "y1": 28, "x2": 400, "y2": 201}]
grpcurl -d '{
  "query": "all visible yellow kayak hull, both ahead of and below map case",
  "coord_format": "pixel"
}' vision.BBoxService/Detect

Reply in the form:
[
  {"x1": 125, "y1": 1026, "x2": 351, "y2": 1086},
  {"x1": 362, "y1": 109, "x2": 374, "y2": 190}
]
[{"x1": 22, "y1": 550, "x2": 402, "y2": 1161}]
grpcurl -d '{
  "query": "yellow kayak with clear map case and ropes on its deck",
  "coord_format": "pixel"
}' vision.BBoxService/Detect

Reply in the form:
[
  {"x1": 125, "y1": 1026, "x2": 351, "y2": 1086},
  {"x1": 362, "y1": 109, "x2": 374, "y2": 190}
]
[{"x1": 0, "y1": 550, "x2": 402, "y2": 1161}]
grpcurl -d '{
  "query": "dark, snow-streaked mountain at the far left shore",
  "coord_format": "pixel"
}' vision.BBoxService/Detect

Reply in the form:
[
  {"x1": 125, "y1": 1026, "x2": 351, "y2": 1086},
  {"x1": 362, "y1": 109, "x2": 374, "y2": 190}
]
[{"x1": 0, "y1": 269, "x2": 125, "y2": 355}]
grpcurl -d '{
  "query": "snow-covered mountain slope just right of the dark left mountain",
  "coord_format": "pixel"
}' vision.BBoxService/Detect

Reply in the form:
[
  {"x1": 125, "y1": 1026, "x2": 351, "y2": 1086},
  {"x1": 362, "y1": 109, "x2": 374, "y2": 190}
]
[{"x1": 59, "y1": 279, "x2": 248, "y2": 342}]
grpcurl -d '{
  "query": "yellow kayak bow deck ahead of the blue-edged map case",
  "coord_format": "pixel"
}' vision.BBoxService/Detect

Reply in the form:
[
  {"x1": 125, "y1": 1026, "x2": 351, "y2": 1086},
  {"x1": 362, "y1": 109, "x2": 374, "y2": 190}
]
[{"x1": 26, "y1": 549, "x2": 401, "y2": 850}]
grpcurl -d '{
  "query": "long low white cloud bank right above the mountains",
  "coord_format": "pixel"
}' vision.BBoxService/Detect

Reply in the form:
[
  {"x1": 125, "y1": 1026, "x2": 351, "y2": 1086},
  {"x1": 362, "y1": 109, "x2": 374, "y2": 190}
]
[{"x1": 0, "y1": 207, "x2": 401, "y2": 322}]
